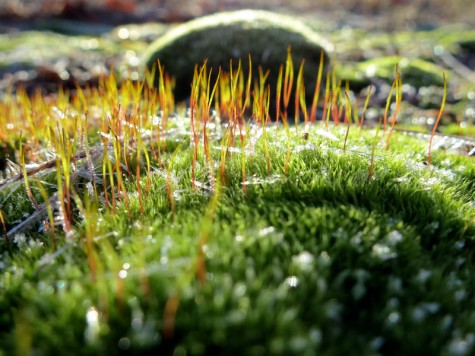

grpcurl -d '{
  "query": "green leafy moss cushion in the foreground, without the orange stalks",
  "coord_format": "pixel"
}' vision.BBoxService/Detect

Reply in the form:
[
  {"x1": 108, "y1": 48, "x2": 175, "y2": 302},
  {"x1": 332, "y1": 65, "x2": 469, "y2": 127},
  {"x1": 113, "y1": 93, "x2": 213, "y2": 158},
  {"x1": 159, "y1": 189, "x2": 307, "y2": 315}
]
[{"x1": 0, "y1": 121, "x2": 475, "y2": 354}]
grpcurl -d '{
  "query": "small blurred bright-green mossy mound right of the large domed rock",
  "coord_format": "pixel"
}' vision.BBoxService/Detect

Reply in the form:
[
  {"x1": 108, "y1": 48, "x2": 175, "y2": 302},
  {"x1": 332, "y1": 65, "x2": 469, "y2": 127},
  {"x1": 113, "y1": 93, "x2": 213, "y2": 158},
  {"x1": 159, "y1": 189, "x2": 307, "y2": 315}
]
[{"x1": 340, "y1": 56, "x2": 449, "y2": 88}]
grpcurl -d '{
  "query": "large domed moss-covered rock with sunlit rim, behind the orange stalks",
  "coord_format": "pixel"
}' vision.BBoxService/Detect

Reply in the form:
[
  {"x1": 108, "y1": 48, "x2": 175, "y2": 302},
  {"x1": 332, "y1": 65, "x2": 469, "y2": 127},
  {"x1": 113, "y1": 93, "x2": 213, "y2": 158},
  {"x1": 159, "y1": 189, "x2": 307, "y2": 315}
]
[{"x1": 143, "y1": 10, "x2": 332, "y2": 105}]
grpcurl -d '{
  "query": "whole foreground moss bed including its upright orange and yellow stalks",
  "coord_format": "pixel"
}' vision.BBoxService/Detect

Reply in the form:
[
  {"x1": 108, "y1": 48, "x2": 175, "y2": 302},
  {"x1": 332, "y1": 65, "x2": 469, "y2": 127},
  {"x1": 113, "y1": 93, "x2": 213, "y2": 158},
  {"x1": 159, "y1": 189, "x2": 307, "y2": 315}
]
[{"x1": 0, "y1": 46, "x2": 475, "y2": 355}]
